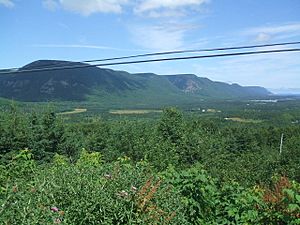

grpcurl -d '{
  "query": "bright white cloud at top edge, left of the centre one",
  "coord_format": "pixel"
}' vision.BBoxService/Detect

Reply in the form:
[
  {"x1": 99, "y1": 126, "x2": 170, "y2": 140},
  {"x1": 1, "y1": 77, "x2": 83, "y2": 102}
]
[{"x1": 43, "y1": 0, "x2": 128, "y2": 16}]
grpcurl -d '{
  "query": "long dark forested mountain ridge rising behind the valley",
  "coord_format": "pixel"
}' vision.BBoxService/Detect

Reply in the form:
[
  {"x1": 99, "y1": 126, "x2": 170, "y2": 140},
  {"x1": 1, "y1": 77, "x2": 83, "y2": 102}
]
[{"x1": 0, "y1": 60, "x2": 270, "y2": 104}]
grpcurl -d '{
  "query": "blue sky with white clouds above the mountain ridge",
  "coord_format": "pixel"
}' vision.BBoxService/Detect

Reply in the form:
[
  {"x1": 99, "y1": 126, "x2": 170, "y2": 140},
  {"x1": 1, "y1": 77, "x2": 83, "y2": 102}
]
[{"x1": 0, "y1": 0, "x2": 300, "y2": 92}]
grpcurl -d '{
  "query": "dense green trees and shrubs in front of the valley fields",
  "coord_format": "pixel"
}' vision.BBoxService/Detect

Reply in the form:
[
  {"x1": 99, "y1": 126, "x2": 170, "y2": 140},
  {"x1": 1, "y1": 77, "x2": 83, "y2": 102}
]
[{"x1": 0, "y1": 105, "x2": 300, "y2": 224}]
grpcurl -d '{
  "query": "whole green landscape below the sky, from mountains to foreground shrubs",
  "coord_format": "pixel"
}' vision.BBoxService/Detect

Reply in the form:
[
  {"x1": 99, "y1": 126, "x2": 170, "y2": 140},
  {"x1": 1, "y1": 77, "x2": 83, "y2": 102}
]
[{"x1": 0, "y1": 61, "x2": 300, "y2": 224}]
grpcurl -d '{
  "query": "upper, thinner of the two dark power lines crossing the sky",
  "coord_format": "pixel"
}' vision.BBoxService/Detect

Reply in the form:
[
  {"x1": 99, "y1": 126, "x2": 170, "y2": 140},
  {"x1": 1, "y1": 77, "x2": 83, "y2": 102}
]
[{"x1": 2, "y1": 41, "x2": 300, "y2": 70}]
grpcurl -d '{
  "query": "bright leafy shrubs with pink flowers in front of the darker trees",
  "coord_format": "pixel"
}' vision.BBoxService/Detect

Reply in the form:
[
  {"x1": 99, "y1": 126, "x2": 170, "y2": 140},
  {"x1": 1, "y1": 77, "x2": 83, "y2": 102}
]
[{"x1": 0, "y1": 150, "x2": 300, "y2": 225}]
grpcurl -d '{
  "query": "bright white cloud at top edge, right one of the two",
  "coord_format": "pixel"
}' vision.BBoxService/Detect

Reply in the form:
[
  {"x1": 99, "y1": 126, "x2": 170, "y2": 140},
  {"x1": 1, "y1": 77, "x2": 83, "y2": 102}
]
[{"x1": 135, "y1": 0, "x2": 208, "y2": 13}]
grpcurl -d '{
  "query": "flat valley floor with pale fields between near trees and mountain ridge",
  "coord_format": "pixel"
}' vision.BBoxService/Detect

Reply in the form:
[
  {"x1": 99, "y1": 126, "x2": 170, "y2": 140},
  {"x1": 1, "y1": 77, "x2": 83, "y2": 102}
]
[{"x1": 0, "y1": 97, "x2": 300, "y2": 125}]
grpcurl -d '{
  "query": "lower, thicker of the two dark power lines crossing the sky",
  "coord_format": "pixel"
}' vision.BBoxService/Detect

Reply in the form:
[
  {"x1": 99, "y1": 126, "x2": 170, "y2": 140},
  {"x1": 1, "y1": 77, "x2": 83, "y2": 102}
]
[{"x1": 0, "y1": 48, "x2": 300, "y2": 74}]
